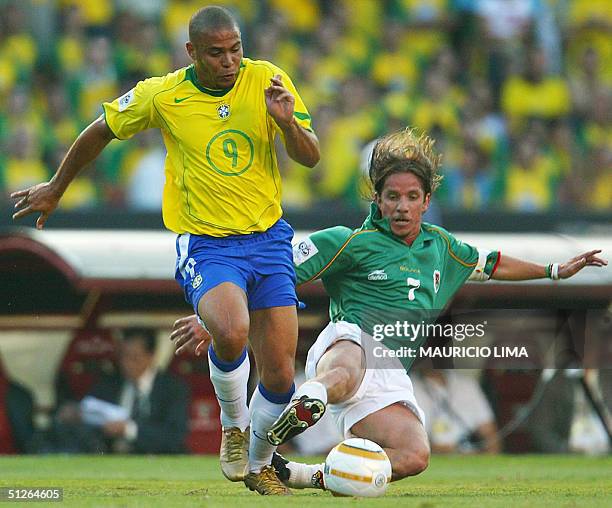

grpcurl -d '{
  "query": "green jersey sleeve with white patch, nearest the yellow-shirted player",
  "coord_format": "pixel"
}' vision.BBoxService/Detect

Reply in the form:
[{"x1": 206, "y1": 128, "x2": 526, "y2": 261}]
[{"x1": 293, "y1": 226, "x2": 353, "y2": 284}]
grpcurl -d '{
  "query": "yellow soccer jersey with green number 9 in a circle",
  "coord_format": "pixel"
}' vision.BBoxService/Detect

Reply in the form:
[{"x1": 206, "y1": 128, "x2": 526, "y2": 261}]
[{"x1": 103, "y1": 58, "x2": 311, "y2": 236}]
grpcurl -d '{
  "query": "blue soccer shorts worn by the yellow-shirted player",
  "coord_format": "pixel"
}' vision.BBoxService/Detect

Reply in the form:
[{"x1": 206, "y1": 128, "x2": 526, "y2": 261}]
[{"x1": 175, "y1": 219, "x2": 298, "y2": 314}]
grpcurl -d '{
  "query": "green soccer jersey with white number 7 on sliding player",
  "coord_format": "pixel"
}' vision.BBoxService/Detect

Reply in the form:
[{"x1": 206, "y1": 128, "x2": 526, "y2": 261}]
[{"x1": 293, "y1": 203, "x2": 500, "y2": 370}]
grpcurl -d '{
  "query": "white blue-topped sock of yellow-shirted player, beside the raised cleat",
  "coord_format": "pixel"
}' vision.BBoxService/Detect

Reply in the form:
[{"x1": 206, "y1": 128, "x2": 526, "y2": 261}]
[{"x1": 249, "y1": 383, "x2": 294, "y2": 473}]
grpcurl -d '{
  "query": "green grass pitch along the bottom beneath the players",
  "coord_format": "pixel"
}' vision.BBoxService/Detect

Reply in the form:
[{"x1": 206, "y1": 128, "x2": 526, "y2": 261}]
[{"x1": 0, "y1": 456, "x2": 612, "y2": 508}]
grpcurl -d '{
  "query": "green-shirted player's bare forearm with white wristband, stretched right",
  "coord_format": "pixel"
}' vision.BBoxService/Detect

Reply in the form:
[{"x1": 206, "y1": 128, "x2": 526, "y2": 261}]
[{"x1": 491, "y1": 250, "x2": 608, "y2": 280}]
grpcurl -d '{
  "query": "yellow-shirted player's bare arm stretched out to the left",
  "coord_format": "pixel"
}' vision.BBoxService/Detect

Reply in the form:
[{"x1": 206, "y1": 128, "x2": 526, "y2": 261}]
[{"x1": 11, "y1": 117, "x2": 114, "y2": 229}]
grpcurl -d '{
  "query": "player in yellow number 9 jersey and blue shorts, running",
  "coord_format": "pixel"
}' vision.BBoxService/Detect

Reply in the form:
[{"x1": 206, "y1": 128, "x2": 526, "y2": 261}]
[{"x1": 11, "y1": 6, "x2": 319, "y2": 494}]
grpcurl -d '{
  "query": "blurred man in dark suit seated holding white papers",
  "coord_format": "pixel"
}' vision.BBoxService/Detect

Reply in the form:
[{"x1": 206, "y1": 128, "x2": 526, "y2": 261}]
[{"x1": 89, "y1": 328, "x2": 189, "y2": 453}]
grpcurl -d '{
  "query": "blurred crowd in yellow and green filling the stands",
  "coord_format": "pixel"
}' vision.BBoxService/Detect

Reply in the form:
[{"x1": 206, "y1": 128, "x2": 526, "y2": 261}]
[{"x1": 0, "y1": 0, "x2": 612, "y2": 212}]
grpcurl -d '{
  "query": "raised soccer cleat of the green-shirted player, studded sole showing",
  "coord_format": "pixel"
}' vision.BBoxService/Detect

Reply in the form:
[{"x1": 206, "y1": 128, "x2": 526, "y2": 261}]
[{"x1": 267, "y1": 395, "x2": 325, "y2": 446}]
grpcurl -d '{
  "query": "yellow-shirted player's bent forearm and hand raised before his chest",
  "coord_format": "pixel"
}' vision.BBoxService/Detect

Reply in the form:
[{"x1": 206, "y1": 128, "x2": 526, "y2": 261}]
[{"x1": 264, "y1": 74, "x2": 321, "y2": 168}]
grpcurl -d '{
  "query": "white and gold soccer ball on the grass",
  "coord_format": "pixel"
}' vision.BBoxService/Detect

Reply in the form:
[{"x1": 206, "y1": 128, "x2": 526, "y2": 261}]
[{"x1": 323, "y1": 437, "x2": 391, "y2": 497}]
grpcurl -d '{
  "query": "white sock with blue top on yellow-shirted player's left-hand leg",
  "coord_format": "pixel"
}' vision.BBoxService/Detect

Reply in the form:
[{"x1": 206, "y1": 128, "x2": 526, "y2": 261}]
[{"x1": 208, "y1": 344, "x2": 251, "y2": 431}]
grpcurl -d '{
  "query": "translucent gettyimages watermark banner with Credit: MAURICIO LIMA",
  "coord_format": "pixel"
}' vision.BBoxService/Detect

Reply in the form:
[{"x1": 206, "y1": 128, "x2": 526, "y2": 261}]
[{"x1": 354, "y1": 309, "x2": 612, "y2": 369}]
